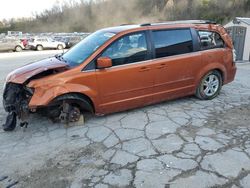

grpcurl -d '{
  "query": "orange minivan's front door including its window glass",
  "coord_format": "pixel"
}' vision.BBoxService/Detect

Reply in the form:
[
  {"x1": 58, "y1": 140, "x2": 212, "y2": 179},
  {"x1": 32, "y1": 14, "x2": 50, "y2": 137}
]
[{"x1": 96, "y1": 32, "x2": 155, "y2": 113}]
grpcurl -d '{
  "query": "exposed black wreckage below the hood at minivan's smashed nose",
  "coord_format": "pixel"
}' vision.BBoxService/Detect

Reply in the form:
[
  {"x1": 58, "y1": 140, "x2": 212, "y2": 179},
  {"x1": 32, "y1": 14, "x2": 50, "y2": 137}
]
[{"x1": 3, "y1": 82, "x2": 33, "y2": 131}]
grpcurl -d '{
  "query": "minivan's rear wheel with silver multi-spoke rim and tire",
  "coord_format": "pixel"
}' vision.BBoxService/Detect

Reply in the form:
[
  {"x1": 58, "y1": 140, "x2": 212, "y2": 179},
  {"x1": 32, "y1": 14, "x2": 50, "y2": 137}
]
[{"x1": 195, "y1": 70, "x2": 222, "y2": 100}]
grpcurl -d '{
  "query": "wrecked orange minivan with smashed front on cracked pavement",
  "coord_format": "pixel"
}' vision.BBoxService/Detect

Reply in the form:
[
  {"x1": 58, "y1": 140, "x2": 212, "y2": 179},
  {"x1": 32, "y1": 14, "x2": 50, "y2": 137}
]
[{"x1": 3, "y1": 20, "x2": 236, "y2": 131}]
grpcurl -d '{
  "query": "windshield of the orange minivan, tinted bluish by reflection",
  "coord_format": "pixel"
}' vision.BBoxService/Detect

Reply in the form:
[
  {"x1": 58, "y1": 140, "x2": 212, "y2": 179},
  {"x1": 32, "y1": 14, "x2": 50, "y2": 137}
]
[{"x1": 62, "y1": 31, "x2": 115, "y2": 66}]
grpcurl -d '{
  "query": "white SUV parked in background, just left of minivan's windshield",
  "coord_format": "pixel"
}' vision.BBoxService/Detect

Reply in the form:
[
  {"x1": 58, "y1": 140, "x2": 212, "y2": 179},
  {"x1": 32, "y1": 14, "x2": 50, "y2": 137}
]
[{"x1": 28, "y1": 38, "x2": 66, "y2": 51}]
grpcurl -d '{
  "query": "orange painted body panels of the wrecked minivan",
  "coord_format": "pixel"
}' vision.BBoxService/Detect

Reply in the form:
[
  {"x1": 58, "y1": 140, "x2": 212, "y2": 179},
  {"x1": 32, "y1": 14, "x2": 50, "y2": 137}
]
[{"x1": 5, "y1": 24, "x2": 236, "y2": 114}]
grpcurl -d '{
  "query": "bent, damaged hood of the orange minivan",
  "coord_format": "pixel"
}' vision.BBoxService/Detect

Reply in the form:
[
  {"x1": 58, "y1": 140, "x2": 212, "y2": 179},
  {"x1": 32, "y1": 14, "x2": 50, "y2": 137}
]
[{"x1": 6, "y1": 57, "x2": 68, "y2": 84}]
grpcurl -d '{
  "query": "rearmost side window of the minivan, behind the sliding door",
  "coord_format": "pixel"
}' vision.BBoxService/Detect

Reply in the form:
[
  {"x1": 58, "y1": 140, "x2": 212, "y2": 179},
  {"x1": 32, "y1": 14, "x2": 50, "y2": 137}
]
[{"x1": 198, "y1": 31, "x2": 225, "y2": 50}]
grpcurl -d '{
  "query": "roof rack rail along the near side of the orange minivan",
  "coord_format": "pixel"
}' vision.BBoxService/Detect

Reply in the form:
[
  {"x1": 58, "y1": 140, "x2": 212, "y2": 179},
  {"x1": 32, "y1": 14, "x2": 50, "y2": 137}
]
[{"x1": 140, "y1": 20, "x2": 217, "y2": 26}]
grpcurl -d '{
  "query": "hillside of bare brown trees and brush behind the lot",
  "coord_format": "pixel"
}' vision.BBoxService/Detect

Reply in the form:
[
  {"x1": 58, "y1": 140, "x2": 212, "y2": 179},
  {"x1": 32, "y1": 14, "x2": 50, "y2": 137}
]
[{"x1": 0, "y1": 0, "x2": 250, "y2": 32}]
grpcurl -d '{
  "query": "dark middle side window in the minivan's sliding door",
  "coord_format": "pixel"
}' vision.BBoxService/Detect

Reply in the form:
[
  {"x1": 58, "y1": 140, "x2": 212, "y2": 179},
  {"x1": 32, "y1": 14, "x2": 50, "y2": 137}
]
[{"x1": 153, "y1": 29, "x2": 193, "y2": 58}]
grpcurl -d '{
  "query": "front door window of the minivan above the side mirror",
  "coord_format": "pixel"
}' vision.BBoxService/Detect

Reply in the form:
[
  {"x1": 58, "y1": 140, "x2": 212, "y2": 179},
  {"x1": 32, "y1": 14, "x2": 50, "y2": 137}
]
[{"x1": 102, "y1": 33, "x2": 147, "y2": 66}]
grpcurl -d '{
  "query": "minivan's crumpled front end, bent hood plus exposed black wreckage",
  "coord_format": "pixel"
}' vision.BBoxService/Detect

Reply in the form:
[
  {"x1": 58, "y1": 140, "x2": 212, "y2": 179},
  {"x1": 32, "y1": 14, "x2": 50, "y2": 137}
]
[{"x1": 3, "y1": 56, "x2": 69, "y2": 131}]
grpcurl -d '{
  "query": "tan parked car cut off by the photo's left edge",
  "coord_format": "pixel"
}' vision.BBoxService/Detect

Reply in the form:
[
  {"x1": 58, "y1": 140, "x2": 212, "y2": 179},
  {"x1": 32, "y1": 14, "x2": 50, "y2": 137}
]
[{"x1": 0, "y1": 38, "x2": 24, "y2": 52}]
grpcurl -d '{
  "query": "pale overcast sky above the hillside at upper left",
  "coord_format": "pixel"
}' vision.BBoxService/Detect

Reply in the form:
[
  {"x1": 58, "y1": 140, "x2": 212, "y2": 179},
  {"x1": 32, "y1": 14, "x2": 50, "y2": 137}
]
[{"x1": 0, "y1": 0, "x2": 67, "y2": 20}]
